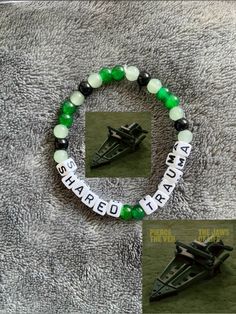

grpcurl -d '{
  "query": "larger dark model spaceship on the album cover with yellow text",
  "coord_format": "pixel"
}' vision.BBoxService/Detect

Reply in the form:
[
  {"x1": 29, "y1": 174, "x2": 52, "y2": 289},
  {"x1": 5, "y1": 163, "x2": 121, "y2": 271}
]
[{"x1": 150, "y1": 240, "x2": 233, "y2": 301}]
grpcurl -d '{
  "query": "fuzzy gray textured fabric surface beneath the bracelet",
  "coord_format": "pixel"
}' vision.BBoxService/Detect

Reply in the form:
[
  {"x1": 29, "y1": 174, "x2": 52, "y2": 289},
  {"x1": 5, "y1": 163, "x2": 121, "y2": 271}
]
[{"x1": 0, "y1": 1, "x2": 236, "y2": 314}]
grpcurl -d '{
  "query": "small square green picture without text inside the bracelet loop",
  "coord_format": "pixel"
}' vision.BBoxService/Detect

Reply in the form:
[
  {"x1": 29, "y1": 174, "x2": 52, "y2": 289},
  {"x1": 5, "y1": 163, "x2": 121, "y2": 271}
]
[{"x1": 85, "y1": 112, "x2": 151, "y2": 177}]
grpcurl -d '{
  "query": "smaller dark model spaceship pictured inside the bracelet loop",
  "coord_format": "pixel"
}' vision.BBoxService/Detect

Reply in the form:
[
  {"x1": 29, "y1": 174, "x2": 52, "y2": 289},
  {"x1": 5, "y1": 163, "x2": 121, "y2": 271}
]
[{"x1": 90, "y1": 122, "x2": 148, "y2": 168}]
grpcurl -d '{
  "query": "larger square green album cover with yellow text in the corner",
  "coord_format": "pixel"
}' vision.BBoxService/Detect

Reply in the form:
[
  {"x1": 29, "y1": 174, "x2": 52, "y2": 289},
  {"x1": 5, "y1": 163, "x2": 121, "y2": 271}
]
[{"x1": 142, "y1": 220, "x2": 236, "y2": 314}]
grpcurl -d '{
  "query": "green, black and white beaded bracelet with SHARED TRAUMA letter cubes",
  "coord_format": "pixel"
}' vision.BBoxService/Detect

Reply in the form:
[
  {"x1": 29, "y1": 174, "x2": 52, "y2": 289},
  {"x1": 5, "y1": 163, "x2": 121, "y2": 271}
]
[{"x1": 53, "y1": 65, "x2": 193, "y2": 220}]
